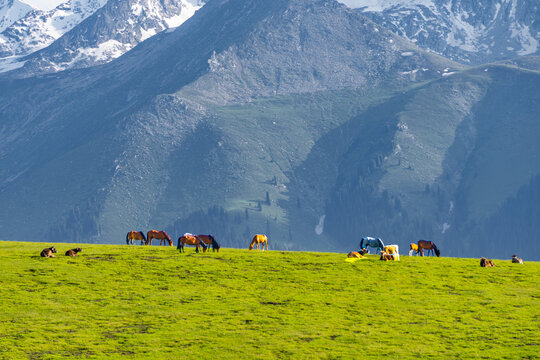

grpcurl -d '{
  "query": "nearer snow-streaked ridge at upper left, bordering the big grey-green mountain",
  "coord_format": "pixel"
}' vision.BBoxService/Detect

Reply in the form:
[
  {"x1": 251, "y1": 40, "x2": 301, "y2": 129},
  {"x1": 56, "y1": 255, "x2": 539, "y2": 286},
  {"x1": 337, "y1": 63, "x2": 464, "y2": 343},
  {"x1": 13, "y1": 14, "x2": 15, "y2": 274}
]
[{"x1": 0, "y1": 0, "x2": 204, "y2": 76}]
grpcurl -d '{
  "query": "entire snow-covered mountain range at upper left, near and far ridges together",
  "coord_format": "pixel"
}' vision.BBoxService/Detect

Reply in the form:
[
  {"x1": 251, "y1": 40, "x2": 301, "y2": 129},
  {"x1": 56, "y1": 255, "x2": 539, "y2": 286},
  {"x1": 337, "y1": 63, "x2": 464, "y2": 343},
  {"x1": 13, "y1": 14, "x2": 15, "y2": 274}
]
[{"x1": 0, "y1": 0, "x2": 202, "y2": 76}]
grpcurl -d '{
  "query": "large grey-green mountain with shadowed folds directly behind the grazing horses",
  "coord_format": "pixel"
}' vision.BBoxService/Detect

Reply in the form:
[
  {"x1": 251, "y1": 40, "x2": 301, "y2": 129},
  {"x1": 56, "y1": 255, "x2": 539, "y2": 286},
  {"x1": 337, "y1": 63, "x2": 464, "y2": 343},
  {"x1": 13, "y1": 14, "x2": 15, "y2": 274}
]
[{"x1": 0, "y1": 0, "x2": 540, "y2": 256}]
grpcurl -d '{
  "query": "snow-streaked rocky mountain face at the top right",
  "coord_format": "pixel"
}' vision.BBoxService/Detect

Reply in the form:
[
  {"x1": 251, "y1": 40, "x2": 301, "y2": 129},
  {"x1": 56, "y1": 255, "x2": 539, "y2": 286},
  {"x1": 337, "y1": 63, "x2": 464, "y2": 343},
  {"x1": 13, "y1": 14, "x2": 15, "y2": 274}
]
[{"x1": 343, "y1": 0, "x2": 540, "y2": 65}]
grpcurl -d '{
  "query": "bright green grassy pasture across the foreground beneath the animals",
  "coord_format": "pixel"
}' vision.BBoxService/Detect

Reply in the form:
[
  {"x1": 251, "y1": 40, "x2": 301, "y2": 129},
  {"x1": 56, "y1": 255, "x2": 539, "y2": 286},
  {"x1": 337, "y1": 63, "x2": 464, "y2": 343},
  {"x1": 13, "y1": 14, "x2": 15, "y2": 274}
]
[{"x1": 0, "y1": 242, "x2": 540, "y2": 359}]
